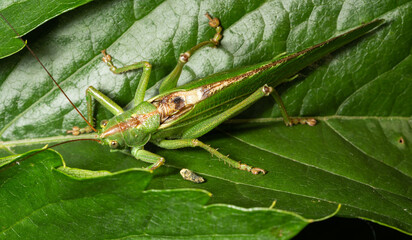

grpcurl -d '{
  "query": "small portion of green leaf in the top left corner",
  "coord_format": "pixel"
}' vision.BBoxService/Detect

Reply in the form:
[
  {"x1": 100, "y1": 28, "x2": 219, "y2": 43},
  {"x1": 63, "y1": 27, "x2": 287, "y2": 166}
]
[{"x1": 0, "y1": 0, "x2": 91, "y2": 59}]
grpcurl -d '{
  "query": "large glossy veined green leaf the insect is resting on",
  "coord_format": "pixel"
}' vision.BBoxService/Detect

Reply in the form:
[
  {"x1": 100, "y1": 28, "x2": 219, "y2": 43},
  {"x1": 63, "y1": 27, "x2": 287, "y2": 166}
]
[{"x1": 0, "y1": 0, "x2": 412, "y2": 236}]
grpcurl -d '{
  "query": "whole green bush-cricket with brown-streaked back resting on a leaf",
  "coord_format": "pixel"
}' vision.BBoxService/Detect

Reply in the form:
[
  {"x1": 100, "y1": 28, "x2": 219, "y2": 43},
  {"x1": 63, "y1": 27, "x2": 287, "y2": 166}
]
[{"x1": 1, "y1": 14, "x2": 384, "y2": 174}]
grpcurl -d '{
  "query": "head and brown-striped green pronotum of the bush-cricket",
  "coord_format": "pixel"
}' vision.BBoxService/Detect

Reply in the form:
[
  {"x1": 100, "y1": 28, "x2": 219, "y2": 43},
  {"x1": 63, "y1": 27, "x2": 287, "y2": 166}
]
[{"x1": 99, "y1": 102, "x2": 160, "y2": 149}]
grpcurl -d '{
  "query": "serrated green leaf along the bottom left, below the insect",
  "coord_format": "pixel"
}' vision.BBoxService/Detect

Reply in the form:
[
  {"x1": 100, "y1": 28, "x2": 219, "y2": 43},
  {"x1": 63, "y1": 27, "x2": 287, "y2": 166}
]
[{"x1": 0, "y1": 150, "x2": 312, "y2": 239}]
